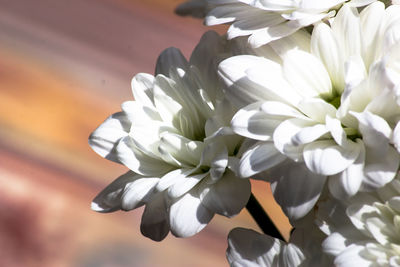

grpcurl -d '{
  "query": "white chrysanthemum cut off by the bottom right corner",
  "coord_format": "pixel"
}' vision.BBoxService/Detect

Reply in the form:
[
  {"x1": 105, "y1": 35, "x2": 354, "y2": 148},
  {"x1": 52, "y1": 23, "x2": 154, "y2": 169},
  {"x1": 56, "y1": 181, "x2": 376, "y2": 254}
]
[{"x1": 320, "y1": 178, "x2": 400, "y2": 267}]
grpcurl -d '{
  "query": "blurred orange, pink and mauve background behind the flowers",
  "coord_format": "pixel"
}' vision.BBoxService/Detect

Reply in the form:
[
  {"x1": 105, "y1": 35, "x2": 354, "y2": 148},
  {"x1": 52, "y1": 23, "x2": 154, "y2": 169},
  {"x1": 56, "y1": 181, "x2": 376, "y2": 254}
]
[{"x1": 0, "y1": 0, "x2": 289, "y2": 267}]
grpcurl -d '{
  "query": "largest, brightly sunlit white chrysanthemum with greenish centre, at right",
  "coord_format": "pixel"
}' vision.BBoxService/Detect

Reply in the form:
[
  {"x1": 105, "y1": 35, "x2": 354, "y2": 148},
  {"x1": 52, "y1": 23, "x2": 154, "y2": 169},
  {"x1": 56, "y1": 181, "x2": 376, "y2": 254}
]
[{"x1": 219, "y1": 2, "x2": 400, "y2": 222}]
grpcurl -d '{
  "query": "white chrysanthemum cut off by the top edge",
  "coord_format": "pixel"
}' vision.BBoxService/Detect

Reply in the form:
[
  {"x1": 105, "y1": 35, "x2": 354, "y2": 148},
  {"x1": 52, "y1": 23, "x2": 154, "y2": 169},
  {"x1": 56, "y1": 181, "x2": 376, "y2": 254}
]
[{"x1": 205, "y1": 0, "x2": 375, "y2": 47}]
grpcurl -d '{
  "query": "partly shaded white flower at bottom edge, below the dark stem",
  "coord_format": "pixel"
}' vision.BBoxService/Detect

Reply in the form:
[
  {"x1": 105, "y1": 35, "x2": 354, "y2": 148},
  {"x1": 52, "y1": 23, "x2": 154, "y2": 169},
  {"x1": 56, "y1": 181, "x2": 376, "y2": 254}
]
[{"x1": 226, "y1": 224, "x2": 333, "y2": 267}]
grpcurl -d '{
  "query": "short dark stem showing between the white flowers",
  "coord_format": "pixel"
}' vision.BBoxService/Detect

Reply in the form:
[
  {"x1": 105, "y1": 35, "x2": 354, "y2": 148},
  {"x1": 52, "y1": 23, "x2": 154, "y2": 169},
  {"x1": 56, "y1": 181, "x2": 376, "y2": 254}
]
[{"x1": 246, "y1": 193, "x2": 285, "y2": 241}]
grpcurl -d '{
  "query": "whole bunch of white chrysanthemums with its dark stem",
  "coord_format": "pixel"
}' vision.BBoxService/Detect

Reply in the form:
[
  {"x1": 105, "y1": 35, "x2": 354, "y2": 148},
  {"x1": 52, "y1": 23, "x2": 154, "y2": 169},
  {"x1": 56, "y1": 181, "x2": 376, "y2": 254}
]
[{"x1": 89, "y1": 0, "x2": 400, "y2": 266}]
